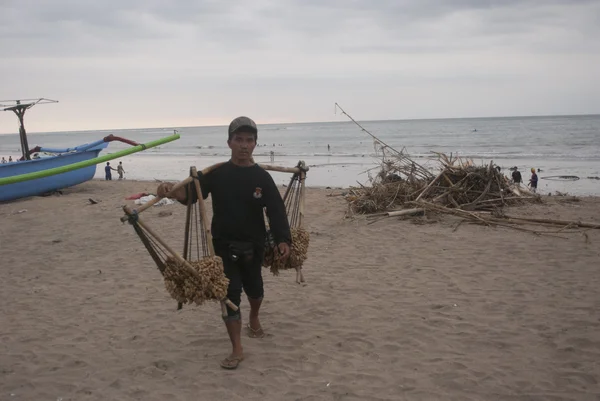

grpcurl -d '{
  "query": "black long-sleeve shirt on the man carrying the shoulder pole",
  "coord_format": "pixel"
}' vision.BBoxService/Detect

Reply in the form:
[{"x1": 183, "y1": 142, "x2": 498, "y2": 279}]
[{"x1": 192, "y1": 161, "x2": 292, "y2": 246}]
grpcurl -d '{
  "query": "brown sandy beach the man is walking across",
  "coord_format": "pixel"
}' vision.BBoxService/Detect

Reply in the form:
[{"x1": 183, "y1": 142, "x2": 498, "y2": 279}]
[{"x1": 0, "y1": 180, "x2": 600, "y2": 401}]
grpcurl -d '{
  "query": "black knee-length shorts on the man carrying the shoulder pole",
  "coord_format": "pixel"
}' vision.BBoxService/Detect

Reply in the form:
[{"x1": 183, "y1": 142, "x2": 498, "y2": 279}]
[{"x1": 213, "y1": 240, "x2": 264, "y2": 317}]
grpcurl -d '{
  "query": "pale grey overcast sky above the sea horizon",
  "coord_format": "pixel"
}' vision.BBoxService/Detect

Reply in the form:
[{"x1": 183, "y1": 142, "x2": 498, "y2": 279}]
[{"x1": 0, "y1": 0, "x2": 600, "y2": 133}]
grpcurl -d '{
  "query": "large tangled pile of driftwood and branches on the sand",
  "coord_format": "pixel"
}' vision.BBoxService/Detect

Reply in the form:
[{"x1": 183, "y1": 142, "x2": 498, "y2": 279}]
[{"x1": 336, "y1": 104, "x2": 600, "y2": 241}]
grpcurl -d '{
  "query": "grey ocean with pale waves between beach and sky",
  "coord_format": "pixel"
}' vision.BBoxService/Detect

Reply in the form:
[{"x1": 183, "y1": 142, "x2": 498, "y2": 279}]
[{"x1": 0, "y1": 115, "x2": 600, "y2": 195}]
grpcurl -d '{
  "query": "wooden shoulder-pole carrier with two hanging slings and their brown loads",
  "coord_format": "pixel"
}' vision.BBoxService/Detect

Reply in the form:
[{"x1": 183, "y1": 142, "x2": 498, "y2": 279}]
[{"x1": 121, "y1": 162, "x2": 308, "y2": 316}]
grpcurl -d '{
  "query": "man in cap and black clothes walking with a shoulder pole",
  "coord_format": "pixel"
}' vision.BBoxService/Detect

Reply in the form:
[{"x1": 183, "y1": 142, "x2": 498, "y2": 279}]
[{"x1": 156, "y1": 117, "x2": 291, "y2": 369}]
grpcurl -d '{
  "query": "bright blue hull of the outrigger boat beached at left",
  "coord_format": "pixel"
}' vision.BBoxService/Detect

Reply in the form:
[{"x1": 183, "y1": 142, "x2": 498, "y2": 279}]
[{"x1": 0, "y1": 143, "x2": 108, "y2": 202}]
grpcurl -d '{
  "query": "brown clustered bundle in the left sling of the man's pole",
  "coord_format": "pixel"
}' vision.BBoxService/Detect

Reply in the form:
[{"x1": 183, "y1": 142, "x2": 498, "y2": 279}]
[{"x1": 163, "y1": 256, "x2": 229, "y2": 305}]
